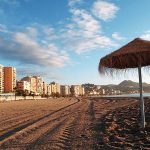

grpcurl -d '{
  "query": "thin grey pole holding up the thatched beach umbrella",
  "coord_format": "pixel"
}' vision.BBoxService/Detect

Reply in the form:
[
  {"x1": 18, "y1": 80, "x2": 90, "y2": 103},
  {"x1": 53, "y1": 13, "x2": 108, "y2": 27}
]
[{"x1": 138, "y1": 66, "x2": 145, "y2": 128}]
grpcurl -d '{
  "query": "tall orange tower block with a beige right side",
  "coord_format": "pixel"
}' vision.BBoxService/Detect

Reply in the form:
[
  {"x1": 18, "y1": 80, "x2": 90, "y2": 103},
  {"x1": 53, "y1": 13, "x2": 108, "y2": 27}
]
[{"x1": 3, "y1": 67, "x2": 16, "y2": 93}]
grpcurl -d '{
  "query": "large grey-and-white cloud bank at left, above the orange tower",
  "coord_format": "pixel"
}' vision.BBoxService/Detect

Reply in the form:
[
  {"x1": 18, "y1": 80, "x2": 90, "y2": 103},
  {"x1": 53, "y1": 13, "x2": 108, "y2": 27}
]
[{"x1": 0, "y1": 32, "x2": 70, "y2": 67}]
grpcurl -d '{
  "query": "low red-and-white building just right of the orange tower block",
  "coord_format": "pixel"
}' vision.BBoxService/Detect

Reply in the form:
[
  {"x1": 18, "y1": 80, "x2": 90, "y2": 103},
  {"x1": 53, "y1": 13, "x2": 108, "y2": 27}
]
[{"x1": 17, "y1": 81, "x2": 30, "y2": 93}]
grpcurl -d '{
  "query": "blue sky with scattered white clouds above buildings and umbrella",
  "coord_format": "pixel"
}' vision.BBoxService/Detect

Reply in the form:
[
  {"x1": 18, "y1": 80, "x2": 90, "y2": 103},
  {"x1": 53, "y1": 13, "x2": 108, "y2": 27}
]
[{"x1": 0, "y1": 0, "x2": 150, "y2": 84}]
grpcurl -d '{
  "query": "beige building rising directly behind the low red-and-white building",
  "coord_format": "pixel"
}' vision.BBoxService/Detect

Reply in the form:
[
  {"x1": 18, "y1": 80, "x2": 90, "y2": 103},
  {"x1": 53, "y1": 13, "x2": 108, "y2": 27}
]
[{"x1": 21, "y1": 76, "x2": 37, "y2": 94}]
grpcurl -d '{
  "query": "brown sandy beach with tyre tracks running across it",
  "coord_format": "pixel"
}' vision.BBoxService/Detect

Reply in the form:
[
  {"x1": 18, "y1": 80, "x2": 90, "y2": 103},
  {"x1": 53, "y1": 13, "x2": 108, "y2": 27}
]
[{"x1": 0, "y1": 98, "x2": 150, "y2": 150}]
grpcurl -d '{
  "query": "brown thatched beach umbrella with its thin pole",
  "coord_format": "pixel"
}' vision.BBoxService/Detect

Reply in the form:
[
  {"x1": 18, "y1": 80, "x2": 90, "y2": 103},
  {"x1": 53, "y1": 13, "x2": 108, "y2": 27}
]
[{"x1": 99, "y1": 38, "x2": 150, "y2": 128}]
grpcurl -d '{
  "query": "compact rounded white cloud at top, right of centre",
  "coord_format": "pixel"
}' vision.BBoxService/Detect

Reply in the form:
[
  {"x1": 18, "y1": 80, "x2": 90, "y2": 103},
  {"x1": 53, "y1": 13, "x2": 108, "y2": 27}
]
[{"x1": 92, "y1": 0, "x2": 119, "y2": 21}]
